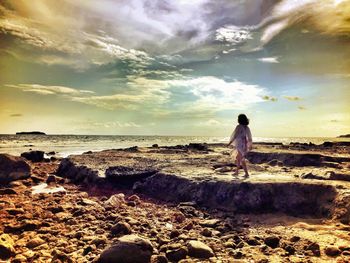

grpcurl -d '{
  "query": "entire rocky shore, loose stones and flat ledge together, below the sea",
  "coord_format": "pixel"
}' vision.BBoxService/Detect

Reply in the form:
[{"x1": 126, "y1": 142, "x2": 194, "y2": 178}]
[{"x1": 0, "y1": 143, "x2": 350, "y2": 263}]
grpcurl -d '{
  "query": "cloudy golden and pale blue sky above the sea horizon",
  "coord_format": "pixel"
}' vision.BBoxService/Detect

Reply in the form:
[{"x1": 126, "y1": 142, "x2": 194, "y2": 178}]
[{"x1": 0, "y1": 0, "x2": 350, "y2": 137}]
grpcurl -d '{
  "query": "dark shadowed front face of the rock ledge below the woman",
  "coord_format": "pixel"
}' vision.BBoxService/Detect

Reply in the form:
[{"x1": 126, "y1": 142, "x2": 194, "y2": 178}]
[{"x1": 134, "y1": 173, "x2": 337, "y2": 217}]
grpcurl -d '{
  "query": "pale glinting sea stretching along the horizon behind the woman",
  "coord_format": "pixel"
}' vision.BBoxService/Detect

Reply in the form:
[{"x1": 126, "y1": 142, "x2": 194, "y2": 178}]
[{"x1": 0, "y1": 134, "x2": 350, "y2": 157}]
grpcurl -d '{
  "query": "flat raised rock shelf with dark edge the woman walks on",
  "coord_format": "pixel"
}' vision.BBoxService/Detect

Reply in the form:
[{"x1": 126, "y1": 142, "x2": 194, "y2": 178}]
[{"x1": 57, "y1": 144, "x2": 350, "y2": 221}]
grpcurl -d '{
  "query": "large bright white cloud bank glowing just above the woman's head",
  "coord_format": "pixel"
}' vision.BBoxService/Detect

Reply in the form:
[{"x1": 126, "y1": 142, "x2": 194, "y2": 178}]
[{"x1": 70, "y1": 76, "x2": 264, "y2": 116}]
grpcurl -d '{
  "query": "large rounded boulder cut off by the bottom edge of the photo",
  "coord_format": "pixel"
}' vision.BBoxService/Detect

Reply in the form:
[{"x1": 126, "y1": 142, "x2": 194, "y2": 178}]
[{"x1": 98, "y1": 235, "x2": 153, "y2": 263}]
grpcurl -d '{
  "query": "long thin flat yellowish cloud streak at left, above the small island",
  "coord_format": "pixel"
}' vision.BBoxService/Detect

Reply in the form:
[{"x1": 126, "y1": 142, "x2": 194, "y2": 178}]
[{"x1": 5, "y1": 84, "x2": 94, "y2": 96}]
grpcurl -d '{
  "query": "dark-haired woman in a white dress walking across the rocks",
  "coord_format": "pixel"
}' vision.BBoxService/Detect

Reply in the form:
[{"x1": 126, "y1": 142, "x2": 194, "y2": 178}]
[{"x1": 227, "y1": 114, "x2": 252, "y2": 177}]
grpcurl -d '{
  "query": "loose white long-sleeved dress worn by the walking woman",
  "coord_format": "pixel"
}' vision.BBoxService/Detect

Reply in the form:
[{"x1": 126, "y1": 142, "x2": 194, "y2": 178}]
[{"x1": 229, "y1": 124, "x2": 253, "y2": 156}]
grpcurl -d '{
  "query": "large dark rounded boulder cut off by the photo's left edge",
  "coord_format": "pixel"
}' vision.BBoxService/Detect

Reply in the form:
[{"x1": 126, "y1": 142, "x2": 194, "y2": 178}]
[{"x1": 0, "y1": 154, "x2": 31, "y2": 183}]
